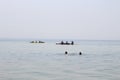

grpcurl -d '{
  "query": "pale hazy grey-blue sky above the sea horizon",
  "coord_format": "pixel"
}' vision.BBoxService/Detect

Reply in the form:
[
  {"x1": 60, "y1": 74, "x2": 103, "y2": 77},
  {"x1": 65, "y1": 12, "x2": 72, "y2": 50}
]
[{"x1": 0, "y1": 0, "x2": 120, "y2": 40}]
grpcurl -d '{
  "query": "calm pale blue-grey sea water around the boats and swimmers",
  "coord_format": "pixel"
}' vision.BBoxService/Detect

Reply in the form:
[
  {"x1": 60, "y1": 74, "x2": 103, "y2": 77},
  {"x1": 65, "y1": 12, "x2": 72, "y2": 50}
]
[{"x1": 0, "y1": 41, "x2": 120, "y2": 80}]
